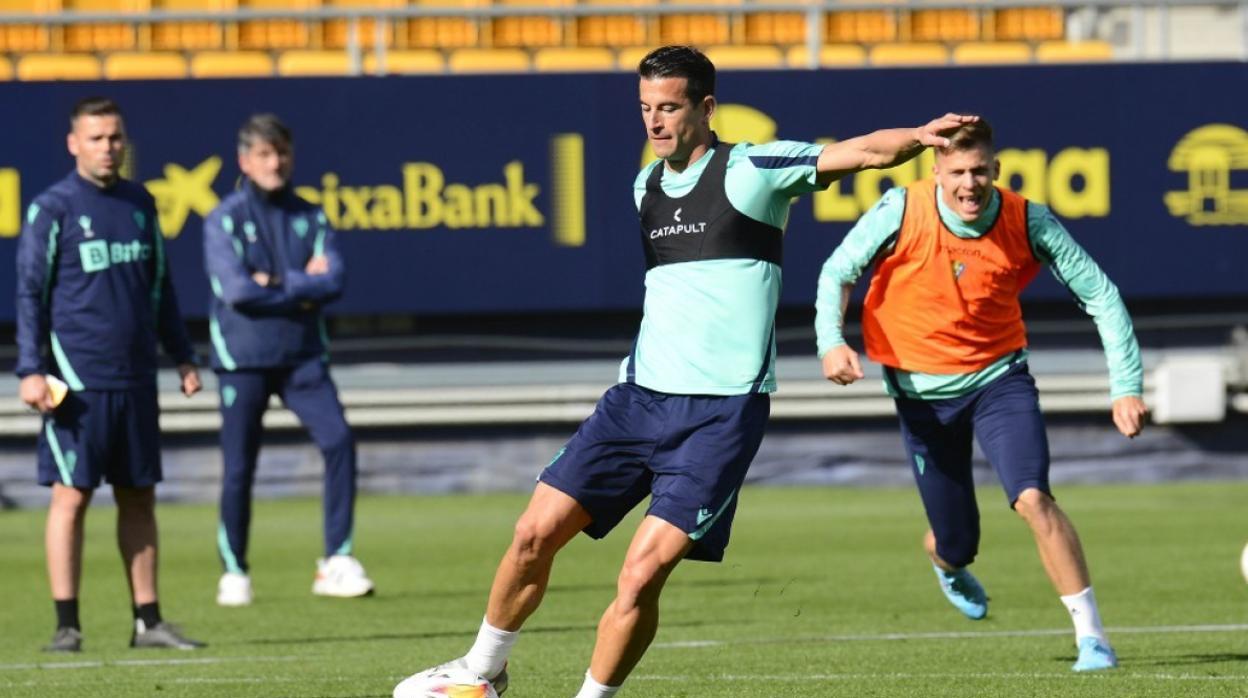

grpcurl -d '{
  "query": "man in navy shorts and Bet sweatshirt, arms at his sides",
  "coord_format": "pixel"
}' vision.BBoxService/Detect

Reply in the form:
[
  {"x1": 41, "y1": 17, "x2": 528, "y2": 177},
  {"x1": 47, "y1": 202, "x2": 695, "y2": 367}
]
[{"x1": 16, "y1": 97, "x2": 202, "y2": 652}]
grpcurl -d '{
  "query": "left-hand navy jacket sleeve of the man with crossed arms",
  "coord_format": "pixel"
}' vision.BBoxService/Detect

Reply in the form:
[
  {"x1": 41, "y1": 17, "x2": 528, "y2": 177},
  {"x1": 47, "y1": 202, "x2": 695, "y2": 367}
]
[{"x1": 203, "y1": 209, "x2": 297, "y2": 315}]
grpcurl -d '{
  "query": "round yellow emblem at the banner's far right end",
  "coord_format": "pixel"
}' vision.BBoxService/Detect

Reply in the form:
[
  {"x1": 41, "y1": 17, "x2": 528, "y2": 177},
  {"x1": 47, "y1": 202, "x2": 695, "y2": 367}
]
[{"x1": 1166, "y1": 124, "x2": 1248, "y2": 226}]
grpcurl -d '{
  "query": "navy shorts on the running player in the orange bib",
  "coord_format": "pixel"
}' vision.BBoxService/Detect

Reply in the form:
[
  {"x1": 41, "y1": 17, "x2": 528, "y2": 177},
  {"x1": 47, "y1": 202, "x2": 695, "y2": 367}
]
[{"x1": 896, "y1": 363, "x2": 1051, "y2": 567}]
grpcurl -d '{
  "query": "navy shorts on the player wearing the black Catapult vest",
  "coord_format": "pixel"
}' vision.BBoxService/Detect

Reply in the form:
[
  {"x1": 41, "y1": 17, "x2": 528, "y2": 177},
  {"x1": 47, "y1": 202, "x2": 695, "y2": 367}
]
[{"x1": 538, "y1": 383, "x2": 771, "y2": 562}]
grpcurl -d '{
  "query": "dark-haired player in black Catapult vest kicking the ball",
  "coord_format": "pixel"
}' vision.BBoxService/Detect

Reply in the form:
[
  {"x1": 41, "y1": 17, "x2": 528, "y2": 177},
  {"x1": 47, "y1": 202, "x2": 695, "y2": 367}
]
[{"x1": 394, "y1": 46, "x2": 973, "y2": 698}]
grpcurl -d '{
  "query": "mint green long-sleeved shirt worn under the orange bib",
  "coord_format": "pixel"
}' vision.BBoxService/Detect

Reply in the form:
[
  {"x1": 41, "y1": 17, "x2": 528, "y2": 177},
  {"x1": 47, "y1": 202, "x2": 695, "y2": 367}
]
[{"x1": 815, "y1": 187, "x2": 1144, "y2": 400}]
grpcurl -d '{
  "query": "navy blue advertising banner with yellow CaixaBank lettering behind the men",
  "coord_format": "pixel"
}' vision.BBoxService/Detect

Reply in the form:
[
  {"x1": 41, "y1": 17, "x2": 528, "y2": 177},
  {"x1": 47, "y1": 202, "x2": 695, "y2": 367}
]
[{"x1": 0, "y1": 64, "x2": 1248, "y2": 321}]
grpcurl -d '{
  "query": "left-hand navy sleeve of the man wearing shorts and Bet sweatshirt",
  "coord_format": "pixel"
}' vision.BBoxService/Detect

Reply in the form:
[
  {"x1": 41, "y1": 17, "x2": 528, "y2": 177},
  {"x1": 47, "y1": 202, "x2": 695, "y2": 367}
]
[{"x1": 15, "y1": 200, "x2": 61, "y2": 378}]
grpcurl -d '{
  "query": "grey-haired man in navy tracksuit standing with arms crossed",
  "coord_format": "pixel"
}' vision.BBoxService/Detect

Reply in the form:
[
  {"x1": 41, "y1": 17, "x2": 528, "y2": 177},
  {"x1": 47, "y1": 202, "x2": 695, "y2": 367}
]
[{"x1": 203, "y1": 114, "x2": 373, "y2": 606}]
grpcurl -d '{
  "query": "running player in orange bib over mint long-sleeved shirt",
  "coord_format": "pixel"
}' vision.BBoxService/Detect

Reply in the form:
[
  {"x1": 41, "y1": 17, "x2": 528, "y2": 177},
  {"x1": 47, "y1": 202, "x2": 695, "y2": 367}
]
[{"x1": 815, "y1": 119, "x2": 1146, "y2": 672}]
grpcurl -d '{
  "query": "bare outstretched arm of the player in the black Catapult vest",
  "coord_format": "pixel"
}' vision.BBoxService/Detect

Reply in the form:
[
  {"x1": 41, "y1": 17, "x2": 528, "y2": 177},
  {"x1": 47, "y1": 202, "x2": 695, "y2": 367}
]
[{"x1": 816, "y1": 114, "x2": 980, "y2": 185}]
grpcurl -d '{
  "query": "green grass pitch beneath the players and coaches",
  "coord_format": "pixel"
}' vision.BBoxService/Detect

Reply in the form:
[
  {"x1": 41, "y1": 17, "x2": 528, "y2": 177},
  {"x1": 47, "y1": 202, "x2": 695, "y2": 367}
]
[{"x1": 0, "y1": 483, "x2": 1248, "y2": 698}]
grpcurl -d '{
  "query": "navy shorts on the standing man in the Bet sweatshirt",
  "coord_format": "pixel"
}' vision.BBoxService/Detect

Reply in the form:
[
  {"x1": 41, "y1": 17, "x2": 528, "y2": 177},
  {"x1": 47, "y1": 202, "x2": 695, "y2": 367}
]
[{"x1": 39, "y1": 387, "x2": 161, "y2": 489}]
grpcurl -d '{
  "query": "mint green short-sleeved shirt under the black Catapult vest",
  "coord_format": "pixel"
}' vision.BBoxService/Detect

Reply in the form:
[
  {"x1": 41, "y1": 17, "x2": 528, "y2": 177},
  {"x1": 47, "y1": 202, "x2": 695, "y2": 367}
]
[{"x1": 619, "y1": 141, "x2": 824, "y2": 395}]
